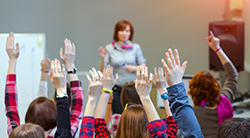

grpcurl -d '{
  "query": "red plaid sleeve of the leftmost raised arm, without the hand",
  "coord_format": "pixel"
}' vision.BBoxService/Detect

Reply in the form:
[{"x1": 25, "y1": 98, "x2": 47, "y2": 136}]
[{"x1": 4, "y1": 74, "x2": 20, "y2": 135}]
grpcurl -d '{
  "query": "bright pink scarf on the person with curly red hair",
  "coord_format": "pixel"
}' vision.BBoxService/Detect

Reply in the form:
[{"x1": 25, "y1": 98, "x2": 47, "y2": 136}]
[{"x1": 200, "y1": 95, "x2": 233, "y2": 125}]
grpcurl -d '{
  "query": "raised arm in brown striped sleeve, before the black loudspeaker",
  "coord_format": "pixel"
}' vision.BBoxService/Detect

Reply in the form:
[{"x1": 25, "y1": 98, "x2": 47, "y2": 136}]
[{"x1": 206, "y1": 31, "x2": 238, "y2": 102}]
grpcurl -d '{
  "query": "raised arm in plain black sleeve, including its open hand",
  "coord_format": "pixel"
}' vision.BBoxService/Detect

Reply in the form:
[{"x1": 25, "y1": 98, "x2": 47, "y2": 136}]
[{"x1": 49, "y1": 58, "x2": 72, "y2": 138}]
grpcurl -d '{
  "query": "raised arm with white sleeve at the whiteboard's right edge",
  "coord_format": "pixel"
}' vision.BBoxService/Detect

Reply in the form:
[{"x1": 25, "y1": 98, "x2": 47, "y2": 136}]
[{"x1": 37, "y1": 54, "x2": 50, "y2": 97}]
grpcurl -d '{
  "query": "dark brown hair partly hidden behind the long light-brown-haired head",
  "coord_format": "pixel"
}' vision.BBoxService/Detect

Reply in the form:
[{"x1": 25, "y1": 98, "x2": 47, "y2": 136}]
[{"x1": 121, "y1": 81, "x2": 141, "y2": 109}]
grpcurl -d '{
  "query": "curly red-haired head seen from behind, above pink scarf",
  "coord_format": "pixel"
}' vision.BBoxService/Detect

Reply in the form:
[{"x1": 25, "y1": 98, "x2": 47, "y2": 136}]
[{"x1": 188, "y1": 71, "x2": 220, "y2": 107}]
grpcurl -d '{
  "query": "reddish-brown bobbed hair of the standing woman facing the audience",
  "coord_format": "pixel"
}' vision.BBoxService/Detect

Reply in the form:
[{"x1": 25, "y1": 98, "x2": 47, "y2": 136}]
[{"x1": 113, "y1": 20, "x2": 134, "y2": 41}]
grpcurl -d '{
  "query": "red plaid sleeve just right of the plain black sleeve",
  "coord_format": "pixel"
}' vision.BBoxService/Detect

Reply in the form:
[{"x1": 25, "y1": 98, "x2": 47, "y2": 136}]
[{"x1": 70, "y1": 81, "x2": 84, "y2": 137}]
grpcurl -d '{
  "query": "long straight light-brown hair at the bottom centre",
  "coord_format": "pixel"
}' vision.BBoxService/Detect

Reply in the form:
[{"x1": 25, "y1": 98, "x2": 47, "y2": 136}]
[{"x1": 115, "y1": 105, "x2": 151, "y2": 138}]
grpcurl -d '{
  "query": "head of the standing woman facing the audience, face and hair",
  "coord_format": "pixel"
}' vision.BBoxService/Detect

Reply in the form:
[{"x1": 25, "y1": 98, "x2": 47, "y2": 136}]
[{"x1": 113, "y1": 20, "x2": 134, "y2": 42}]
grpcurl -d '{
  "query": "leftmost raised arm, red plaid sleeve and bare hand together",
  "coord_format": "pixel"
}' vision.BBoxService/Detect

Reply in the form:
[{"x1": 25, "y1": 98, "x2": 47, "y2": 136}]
[{"x1": 4, "y1": 33, "x2": 20, "y2": 135}]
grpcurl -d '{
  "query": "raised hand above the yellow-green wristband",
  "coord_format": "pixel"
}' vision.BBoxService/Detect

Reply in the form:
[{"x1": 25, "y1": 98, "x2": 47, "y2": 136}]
[{"x1": 103, "y1": 65, "x2": 118, "y2": 90}]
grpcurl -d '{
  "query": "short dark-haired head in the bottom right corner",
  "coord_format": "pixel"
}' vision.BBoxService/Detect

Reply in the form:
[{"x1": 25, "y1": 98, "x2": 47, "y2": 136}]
[{"x1": 217, "y1": 118, "x2": 250, "y2": 138}]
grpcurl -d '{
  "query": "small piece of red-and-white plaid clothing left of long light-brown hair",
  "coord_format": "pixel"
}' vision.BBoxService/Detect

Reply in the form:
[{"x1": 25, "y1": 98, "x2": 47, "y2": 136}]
[{"x1": 108, "y1": 114, "x2": 121, "y2": 137}]
